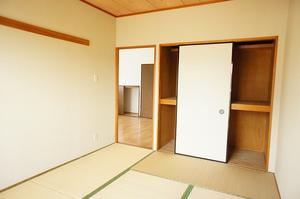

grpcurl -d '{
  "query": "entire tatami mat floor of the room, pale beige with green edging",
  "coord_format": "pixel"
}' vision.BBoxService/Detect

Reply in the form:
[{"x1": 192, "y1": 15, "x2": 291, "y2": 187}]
[{"x1": 0, "y1": 144, "x2": 279, "y2": 199}]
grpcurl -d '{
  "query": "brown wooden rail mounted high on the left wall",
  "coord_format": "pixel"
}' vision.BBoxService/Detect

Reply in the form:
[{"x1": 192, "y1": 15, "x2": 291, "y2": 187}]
[{"x1": 0, "y1": 16, "x2": 90, "y2": 46}]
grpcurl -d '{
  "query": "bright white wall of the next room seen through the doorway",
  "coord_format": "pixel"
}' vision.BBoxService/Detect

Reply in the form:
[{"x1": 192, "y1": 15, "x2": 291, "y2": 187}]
[{"x1": 119, "y1": 48, "x2": 154, "y2": 86}]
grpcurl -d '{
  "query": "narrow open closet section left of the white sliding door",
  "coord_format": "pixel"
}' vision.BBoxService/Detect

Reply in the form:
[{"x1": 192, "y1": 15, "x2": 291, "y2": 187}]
[{"x1": 158, "y1": 46, "x2": 179, "y2": 153}]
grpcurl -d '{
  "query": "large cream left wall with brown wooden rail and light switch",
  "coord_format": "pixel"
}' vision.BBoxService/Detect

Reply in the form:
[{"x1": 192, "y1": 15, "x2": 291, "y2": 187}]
[{"x1": 0, "y1": 0, "x2": 115, "y2": 189}]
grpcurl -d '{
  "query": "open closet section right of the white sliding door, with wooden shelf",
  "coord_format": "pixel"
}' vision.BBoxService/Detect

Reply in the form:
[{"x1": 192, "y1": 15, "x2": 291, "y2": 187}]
[{"x1": 228, "y1": 41, "x2": 275, "y2": 170}]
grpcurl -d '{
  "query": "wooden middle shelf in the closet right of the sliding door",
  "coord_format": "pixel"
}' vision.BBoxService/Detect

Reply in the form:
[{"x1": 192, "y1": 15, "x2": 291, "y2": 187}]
[{"x1": 231, "y1": 101, "x2": 271, "y2": 113}]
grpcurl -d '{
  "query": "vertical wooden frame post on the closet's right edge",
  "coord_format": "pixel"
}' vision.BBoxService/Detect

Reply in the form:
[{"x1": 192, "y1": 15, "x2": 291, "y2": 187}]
[{"x1": 265, "y1": 36, "x2": 278, "y2": 170}]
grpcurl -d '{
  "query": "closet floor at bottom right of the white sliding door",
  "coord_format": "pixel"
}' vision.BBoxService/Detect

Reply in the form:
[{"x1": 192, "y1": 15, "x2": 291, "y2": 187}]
[{"x1": 228, "y1": 149, "x2": 266, "y2": 171}]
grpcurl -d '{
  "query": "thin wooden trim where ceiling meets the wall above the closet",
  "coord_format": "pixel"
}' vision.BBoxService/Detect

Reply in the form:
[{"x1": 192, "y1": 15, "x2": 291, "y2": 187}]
[{"x1": 116, "y1": 0, "x2": 230, "y2": 18}]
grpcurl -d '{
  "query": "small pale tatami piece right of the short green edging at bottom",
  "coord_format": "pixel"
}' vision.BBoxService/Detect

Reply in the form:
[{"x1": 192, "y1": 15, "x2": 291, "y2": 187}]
[{"x1": 188, "y1": 187, "x2": 243, "y2": 199}]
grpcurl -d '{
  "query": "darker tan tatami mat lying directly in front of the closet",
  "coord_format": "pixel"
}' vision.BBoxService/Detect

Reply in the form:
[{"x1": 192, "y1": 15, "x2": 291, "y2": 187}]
[{"x1": 133, "y1": 152, "x2": 279, "y2": 199}]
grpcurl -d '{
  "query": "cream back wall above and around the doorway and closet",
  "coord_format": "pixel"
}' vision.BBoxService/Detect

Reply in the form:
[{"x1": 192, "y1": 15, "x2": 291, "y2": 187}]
[{"x1": 116, "y1": 0, "x2": 289, "y2": 171}]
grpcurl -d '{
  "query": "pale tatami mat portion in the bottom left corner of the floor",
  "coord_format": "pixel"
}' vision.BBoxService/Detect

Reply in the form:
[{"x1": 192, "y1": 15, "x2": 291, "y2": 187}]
[{"x1": 0, "y1": 182, "x2": 71, "y2": 199}]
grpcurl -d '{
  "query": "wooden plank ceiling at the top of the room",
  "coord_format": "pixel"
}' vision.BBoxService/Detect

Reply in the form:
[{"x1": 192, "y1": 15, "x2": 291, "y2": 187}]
[{"x1": 81, "y1": 0, "x2": 228, "y2": 17}]
